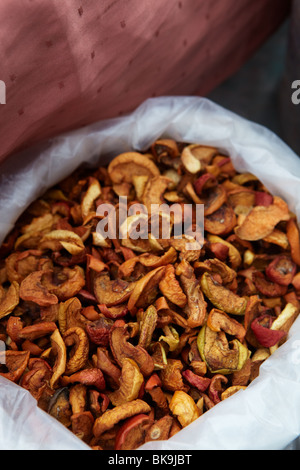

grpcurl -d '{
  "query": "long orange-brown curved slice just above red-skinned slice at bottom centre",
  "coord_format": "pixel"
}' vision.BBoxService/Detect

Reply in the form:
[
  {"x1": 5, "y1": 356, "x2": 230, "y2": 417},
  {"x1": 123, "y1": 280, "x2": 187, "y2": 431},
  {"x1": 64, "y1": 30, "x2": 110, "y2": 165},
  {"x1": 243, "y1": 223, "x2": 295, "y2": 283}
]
[{"x1": 93, "y1": 398, "x2": 151, "y2": 438}]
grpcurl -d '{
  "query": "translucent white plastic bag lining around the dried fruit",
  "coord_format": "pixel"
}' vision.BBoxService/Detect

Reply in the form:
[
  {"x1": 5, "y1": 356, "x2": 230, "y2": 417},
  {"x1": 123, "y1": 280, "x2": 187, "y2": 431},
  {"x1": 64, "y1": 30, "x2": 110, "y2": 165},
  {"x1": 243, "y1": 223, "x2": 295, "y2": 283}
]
[{"x1": 0, "y1": 97, "x2": 300, "y2": 450}]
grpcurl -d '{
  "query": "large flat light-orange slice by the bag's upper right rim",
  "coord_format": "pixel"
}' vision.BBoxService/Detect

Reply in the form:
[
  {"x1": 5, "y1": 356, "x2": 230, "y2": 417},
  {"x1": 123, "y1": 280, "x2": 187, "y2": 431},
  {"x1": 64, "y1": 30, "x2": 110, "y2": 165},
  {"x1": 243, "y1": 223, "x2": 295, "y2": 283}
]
[{"x1": 234, "y1": 196, "x2": 290, "y2": 241}]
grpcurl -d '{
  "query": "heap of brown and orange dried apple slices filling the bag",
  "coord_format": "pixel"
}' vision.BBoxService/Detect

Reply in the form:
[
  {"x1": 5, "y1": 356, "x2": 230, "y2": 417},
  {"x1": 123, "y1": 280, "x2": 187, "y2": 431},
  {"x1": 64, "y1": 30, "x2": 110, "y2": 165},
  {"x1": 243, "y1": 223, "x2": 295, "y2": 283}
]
[{"x1": 0, "y1": 139, "x2": 300, "y2": 450}]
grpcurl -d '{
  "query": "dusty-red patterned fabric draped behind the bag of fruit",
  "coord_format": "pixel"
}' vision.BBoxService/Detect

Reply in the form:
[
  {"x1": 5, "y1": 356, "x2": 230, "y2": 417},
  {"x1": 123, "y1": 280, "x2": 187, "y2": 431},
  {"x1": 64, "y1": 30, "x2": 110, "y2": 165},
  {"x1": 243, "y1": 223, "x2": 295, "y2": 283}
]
[{"x1": 0, "y1": 0, "x2": 289, "y2": 161}]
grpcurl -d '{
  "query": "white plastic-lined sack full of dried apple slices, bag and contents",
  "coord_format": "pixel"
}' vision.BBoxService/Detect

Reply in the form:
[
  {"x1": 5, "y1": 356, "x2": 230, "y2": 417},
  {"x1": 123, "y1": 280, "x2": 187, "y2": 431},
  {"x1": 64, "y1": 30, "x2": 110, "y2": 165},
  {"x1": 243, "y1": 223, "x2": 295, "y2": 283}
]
[{"x1": 0, "y1": 97, "x2": 300, "y2": 450}]
